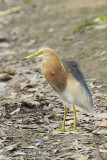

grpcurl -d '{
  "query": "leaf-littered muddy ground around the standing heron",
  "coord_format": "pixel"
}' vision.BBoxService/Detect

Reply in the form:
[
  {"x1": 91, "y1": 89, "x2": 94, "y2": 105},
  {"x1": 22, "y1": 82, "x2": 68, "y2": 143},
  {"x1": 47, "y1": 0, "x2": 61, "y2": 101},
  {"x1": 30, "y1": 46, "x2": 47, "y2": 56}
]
[{"x1": 0, "y1": 0, "x2": 107, "y2": 160}]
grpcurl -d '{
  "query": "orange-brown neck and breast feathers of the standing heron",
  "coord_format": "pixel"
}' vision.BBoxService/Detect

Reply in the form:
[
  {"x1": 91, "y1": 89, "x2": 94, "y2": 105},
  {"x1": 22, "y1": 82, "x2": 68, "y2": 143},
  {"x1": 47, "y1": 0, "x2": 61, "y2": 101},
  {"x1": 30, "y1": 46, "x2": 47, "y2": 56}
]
[{"x1": 41, "y1": 56, "x2": 68, "y2": 93}]
